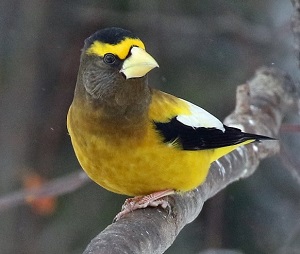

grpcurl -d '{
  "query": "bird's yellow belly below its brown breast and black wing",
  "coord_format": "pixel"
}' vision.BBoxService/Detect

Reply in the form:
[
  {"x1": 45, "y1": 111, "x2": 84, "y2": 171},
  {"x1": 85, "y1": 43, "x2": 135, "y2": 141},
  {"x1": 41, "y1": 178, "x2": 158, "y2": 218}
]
[{"x1": 68, "y1": 114, "x2": 213, "y2": 196}]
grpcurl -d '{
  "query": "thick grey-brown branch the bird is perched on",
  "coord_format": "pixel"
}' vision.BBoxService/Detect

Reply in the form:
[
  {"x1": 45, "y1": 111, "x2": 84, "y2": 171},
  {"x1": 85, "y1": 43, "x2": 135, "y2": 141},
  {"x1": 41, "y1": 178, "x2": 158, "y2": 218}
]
[{"x1": 84, "y1": 67, "x2": 299, "y2": 254}]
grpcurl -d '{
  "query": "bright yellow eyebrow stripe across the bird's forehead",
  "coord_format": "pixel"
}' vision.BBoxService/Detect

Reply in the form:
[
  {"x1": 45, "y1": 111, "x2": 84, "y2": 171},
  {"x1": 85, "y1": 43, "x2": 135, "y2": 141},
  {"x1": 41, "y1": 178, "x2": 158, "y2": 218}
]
[{"x1": 86, "y1": 38, "x2": 145, "y2": 60}]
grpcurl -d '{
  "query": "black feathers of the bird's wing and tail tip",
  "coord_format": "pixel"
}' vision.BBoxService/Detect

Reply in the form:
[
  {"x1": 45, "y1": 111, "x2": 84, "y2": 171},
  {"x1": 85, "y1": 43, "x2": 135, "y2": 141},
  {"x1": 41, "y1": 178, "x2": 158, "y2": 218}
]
[{"x1": 154, "y1": 117, "x2": 273, "y2": 150}]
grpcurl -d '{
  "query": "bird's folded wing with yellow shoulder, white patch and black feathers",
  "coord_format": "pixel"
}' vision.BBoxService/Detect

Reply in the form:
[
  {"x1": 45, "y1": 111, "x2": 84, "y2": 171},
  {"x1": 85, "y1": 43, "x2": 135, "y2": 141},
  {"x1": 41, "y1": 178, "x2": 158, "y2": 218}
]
[{"x1": 149, "y1": 90, "x2": 266, "y2": 150}]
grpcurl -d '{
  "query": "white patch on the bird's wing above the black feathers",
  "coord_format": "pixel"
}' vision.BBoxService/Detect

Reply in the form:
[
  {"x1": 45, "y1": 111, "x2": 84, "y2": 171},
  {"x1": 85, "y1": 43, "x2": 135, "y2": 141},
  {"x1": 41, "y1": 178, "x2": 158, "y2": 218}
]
[{"x1": 176, "y1": 99, "x2": 225, "y2": 132}]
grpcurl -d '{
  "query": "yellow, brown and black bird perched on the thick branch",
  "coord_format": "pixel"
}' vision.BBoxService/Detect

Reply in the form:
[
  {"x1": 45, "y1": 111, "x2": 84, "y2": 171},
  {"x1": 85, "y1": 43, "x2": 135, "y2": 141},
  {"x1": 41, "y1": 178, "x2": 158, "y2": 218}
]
[{"x1": 67, "y1": 27, "x2": 272, "y2": 220}]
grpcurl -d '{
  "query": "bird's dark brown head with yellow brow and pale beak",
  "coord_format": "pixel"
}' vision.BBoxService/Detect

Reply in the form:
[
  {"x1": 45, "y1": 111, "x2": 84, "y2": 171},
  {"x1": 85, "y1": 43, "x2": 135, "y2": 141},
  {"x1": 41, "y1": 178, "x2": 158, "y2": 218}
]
[{"x1": 75, "y1": 27, "x2": 158, "y2": 107}]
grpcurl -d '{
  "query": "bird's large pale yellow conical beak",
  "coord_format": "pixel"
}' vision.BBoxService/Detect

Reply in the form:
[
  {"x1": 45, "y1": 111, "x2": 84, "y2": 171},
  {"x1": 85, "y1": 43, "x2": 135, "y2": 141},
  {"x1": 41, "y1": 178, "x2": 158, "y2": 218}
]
[{"x1": 120, "y1": 47, "x2": 159, "y2": 79}]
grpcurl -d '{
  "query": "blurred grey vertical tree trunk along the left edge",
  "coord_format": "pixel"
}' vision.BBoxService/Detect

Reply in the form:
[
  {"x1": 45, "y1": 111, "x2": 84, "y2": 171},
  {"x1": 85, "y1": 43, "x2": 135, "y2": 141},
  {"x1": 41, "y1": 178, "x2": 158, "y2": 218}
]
[{"x1": 0, "y1": 0, "x2": 48, "y2": 253}]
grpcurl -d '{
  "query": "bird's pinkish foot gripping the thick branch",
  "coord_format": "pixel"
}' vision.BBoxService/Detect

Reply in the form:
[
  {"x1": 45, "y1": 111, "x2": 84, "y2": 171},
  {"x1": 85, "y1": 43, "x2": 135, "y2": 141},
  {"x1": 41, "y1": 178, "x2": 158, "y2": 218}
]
[{"x1": 114, "y1": 189, "x2": 175, "y2": 221}]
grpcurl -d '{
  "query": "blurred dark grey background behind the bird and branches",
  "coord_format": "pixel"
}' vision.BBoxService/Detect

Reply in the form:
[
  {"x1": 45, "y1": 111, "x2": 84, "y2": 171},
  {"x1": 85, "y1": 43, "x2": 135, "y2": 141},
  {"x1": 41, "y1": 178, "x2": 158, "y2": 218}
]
[{"x1": 0, "y1": 0, "x2": 300, "y2": 254}]
